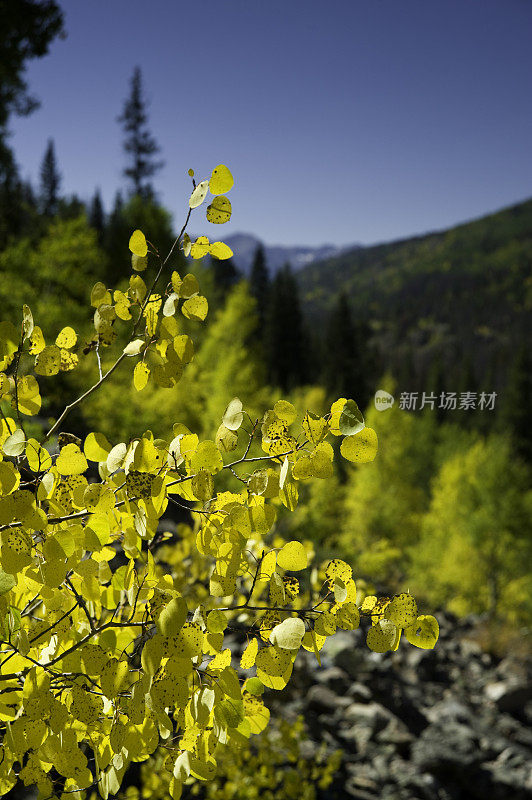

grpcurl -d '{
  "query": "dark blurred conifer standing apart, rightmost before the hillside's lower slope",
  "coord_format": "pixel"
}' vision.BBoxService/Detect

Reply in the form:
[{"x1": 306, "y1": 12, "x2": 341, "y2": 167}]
[{"x1": 323, "y1": 292, "x2": 371, "y2": 407}]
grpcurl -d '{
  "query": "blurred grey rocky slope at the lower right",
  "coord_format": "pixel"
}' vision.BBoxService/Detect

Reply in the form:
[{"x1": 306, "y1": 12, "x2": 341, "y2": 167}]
[{"x1": 241, "y1": 613, "x2": 532, "y2": 800}]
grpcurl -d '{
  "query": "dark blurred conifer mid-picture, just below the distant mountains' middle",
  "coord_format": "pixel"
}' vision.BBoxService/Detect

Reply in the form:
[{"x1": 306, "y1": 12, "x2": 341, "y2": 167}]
[{"x1": 265, "y1": 264, "x2": 309, "y2": 391}]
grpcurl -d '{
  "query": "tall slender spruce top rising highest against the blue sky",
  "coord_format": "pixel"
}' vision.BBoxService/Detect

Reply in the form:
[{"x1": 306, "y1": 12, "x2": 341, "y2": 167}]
[{"x1": 118, "y1": 67, "x2": 163, "y2": 198}]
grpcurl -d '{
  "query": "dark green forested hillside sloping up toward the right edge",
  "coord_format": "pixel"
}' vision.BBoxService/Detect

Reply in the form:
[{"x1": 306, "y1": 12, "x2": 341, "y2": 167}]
[{"x1": 298, "y1": 200, "x2": 532, "y2": 400}]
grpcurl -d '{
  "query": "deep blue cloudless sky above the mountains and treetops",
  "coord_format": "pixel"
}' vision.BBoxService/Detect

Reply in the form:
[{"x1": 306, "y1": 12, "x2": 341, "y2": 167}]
[{"x1": 12, "y1": 0, "x2": 532, "y2": 244}]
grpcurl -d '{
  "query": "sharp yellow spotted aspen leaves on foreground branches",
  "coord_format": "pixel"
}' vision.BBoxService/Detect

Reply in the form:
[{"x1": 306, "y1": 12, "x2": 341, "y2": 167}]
[{"x1": 0, "y1": 165, "x2": 437, "y2": 799}]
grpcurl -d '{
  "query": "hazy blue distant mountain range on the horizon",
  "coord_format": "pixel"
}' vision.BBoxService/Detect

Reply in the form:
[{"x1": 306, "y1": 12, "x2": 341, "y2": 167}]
[{"x1": 218, "y1": 233, "x2": 356, "y2": 275}]
